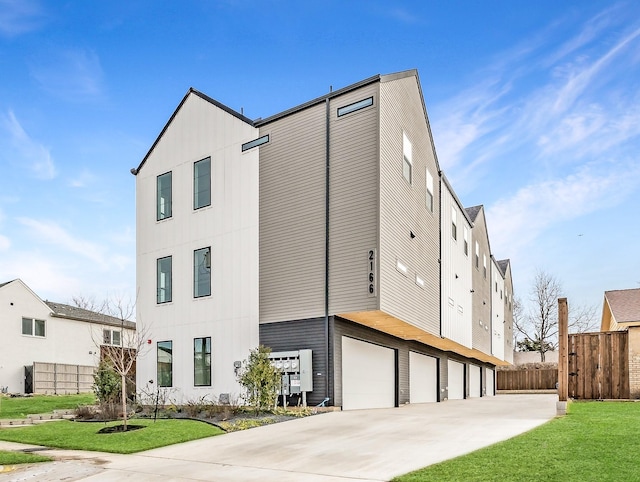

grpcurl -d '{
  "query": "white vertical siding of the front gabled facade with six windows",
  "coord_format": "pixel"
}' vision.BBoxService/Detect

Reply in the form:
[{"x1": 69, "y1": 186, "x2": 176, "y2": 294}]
[{"x1": 136, "y1": 94, "x2": 264, "y2": 399}]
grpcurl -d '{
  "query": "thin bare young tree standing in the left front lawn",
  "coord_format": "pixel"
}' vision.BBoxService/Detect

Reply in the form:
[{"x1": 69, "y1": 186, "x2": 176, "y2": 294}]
[{"x1": 72, "y1": 296, "x2": 148, "y2": 431}]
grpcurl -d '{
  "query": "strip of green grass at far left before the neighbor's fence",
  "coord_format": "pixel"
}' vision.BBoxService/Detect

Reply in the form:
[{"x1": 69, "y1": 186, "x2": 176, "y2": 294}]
[{"x1": 0, "y1": 393, "x2": 96, "y2": 418}]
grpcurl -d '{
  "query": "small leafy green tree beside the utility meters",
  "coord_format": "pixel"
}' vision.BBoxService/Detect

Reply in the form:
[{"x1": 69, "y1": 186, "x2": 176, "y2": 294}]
[{"x1": 238, "y1": 345, "x2": 281, "y2": 414}]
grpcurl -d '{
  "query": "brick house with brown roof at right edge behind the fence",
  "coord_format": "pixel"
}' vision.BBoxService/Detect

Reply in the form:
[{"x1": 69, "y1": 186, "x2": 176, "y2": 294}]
[{"x1": 600, "y1": 288, "x2": 640, "y2": 399}]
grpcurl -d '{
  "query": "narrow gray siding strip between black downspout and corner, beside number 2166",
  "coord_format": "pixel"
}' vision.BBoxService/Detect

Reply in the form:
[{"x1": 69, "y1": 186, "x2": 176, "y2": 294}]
[{"x1": 329, "y1": 83, "x2": 380, "y2": 314}]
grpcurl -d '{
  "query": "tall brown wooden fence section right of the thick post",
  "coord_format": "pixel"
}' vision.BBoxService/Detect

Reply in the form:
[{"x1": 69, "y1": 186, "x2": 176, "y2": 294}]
[{"x1": 568, "y1": 331, "x2": 629, "y2": 400}]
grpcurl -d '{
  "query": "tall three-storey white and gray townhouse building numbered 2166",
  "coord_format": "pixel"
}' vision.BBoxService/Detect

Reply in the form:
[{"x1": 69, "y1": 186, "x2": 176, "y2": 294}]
[{"x1": 132, "y1": 70, "x2": 510, "y2": 409}]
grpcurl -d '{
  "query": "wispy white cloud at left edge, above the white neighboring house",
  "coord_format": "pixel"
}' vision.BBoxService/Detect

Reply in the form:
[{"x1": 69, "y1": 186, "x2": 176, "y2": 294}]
[{"x1": 1, "y1": 111, "x2": 56, "y2": 179}]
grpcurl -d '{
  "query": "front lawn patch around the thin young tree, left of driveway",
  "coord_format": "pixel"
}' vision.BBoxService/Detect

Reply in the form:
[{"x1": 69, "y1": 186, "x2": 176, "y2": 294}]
[{"x1": 0, "y1": 419, "x2": 224, "y2": 454}]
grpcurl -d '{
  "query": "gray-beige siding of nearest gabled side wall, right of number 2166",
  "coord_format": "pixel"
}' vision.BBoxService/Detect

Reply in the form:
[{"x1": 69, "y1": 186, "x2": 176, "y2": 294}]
[{"x1": 379, "y1": 77, "x2": 440, "y2": 335}]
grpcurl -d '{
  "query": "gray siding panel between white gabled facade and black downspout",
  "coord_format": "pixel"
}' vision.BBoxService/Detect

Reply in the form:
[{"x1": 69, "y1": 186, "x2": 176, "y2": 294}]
[{"x1": 260, "y1": 104, "x2": 326, "y2": 322}]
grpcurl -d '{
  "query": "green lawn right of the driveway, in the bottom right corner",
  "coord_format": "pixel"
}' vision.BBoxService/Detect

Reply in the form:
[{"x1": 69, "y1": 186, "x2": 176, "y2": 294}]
[{"x1": 394, "y1": 402, "x2": 640, "y2": 482}]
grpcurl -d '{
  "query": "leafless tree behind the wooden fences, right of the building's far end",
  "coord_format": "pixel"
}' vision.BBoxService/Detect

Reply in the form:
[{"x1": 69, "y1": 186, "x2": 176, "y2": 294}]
[{"x1": 513, "y1": 270, "x2": 596, "y2": 362}]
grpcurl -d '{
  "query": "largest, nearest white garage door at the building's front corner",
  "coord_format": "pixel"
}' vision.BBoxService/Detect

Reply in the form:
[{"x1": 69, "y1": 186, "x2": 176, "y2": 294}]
[{"x1": 342, "y1": 336, "x2": 396, "y2": 410}]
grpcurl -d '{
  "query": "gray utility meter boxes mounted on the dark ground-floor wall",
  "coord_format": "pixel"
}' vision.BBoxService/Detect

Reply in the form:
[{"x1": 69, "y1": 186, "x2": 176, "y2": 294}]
[{"x1": 269, "y1": 350, "x2": 313, "y2": 406}]
